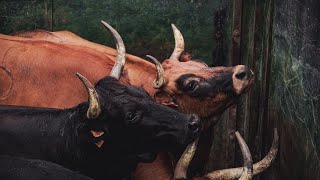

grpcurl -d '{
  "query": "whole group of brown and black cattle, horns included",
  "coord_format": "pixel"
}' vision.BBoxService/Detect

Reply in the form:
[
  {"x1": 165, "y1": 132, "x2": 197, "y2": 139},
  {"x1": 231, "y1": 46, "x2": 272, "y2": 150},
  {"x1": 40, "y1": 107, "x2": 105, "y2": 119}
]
[{"x1": 0, "y1": 21, "x2": 278, "y2": 180}]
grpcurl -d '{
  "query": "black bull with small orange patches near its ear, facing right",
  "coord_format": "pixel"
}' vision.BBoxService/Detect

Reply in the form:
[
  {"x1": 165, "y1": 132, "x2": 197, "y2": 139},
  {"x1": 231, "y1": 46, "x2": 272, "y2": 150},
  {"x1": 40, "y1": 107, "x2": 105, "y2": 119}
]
[{"x1": 0, "y1": 77, "x2": 200, "y2": 179}]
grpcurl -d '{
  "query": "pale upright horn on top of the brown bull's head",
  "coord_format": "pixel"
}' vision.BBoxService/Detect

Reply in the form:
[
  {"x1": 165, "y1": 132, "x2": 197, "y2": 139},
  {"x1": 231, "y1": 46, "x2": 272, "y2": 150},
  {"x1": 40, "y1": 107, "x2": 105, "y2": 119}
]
[{"x1": 170, "y1": 24, "x2": 184, "y2": 61}]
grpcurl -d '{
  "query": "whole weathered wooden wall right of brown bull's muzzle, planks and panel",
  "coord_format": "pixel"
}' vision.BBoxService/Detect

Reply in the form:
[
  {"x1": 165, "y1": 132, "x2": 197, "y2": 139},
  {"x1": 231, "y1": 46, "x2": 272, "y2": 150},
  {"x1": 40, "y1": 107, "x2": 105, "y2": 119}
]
[{"x1": 211, "y1": 0, "x2": 320, "y2": 180}]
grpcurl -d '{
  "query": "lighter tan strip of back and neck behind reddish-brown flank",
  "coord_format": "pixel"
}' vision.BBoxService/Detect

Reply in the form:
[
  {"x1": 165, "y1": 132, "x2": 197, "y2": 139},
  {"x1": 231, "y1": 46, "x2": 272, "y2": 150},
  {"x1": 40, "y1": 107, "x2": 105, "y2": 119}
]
[{"x1": 3, "y1": 30, "x2": 156, "y2": 100}]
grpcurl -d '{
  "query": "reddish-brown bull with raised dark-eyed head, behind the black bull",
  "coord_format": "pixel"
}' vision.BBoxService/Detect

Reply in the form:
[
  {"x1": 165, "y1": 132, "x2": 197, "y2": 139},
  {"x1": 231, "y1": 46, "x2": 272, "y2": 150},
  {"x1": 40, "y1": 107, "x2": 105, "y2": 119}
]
[{"x1": 0, "y1": 21, "x2": 276, "y2": 179}]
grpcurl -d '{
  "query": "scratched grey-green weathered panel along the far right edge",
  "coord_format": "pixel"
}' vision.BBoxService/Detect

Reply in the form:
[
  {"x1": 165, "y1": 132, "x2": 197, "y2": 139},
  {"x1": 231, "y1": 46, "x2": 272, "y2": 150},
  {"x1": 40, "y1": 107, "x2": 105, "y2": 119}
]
[{"x1": 269, "y1": 0, "x2": 320, "y2": 179}]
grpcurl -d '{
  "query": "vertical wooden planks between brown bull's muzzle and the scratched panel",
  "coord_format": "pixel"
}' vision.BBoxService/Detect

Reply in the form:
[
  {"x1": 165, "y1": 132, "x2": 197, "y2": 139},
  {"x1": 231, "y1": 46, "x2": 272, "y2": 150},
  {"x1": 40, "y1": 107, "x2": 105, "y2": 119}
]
[{"x1": 236, "y1": 0, "x2": 273, "y2": 179}]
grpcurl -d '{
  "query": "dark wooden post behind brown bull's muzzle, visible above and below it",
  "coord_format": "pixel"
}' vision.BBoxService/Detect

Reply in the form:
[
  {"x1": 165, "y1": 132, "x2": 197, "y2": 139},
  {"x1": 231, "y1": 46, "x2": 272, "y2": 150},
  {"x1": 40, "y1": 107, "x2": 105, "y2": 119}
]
[{"x1": 206, "y1": 0, "x2": 242, "y2": 172}]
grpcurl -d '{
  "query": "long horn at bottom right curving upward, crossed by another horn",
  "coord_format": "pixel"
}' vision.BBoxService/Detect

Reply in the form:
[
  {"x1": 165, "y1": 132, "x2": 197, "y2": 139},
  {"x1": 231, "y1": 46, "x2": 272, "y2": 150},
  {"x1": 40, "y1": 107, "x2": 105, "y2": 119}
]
[{"x1": 206, "y1": 128, "x2": 279, "y2": 179}]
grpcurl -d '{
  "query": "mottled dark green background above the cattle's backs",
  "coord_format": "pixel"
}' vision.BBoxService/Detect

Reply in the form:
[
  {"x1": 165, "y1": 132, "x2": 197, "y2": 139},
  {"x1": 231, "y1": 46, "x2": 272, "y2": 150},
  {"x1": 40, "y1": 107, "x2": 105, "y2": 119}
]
[{"x1": 0, "y1": 0, "x2": 225, "y2": 63}]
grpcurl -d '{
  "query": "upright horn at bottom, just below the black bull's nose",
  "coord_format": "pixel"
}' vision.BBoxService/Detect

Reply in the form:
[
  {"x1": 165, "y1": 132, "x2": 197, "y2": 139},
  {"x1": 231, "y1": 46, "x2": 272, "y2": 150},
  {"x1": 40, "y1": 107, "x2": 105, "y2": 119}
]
[{"x1": 174, "y1": 139, "x2": 198, "y2": 179}]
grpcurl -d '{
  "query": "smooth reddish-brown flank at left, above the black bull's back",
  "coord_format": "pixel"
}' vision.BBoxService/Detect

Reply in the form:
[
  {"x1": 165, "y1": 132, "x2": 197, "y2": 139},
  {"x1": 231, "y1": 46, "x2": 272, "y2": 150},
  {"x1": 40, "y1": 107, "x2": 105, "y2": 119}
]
[{"x1": 0, "y1": 37, "x2": 107, "y2": 108}]
